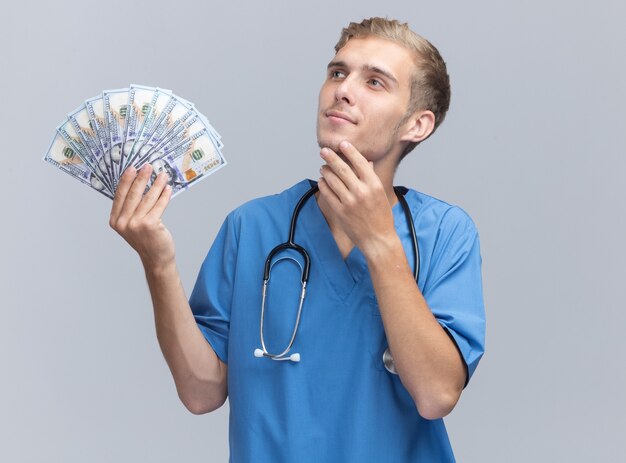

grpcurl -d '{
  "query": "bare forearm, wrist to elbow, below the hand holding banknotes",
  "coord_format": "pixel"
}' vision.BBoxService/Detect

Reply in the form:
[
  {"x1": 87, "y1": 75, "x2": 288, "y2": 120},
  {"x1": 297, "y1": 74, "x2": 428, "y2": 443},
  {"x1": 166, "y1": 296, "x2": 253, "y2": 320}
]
[{"x1": 144, "y1": 261, "x2": 227, "y2": 414}]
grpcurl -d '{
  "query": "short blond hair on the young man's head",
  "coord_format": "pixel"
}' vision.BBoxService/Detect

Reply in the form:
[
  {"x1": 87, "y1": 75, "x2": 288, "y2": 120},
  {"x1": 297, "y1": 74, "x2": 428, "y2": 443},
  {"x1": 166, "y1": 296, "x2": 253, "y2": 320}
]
[{"x1": 335, "y1": 18, "x2": 450, "y2": 157}]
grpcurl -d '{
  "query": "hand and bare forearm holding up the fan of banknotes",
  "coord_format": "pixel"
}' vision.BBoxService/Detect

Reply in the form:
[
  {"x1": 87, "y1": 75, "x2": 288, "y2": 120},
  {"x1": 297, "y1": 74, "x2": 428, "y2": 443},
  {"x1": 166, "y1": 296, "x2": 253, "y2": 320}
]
[{"x1": 109, "y1": 164, "x2": 228, "y2": 414}]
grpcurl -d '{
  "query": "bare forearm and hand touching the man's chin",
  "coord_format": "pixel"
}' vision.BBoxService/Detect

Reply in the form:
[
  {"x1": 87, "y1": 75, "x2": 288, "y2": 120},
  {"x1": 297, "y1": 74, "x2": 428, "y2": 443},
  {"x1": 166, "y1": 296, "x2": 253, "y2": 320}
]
[{"x1": 318, "y1": 141, "x2": 465, "y2": 419}]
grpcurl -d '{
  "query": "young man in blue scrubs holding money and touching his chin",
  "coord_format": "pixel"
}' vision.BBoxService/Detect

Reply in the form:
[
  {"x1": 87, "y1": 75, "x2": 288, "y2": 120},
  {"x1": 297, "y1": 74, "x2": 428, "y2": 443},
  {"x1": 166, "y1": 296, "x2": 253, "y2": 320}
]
[{"x1": 111, "y1": 18, "x2": 484, "y2": 462}]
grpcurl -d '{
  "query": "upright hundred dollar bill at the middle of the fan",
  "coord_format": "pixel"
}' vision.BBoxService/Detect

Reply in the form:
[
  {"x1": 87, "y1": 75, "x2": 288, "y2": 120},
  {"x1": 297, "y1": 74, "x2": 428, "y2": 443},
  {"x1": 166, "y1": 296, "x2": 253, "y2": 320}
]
[{"x1": 102, "y1": 88, "x2": 128, "y2": 183}]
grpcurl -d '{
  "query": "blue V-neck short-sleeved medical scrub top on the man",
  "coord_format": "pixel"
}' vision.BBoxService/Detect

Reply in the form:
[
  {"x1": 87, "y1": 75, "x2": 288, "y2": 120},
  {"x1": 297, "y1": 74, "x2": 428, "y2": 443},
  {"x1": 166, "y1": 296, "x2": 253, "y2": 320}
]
[{"x1": 190, "y1": 180, "x2": 485, "y2": 463}]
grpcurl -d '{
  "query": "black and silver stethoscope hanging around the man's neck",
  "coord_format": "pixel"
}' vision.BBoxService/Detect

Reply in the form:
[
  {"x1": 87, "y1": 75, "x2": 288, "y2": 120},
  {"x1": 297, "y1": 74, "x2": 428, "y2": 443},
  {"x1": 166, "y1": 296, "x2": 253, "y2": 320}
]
[{"x1": 254, "y1": 183, "x2": 419, "y2": 375}]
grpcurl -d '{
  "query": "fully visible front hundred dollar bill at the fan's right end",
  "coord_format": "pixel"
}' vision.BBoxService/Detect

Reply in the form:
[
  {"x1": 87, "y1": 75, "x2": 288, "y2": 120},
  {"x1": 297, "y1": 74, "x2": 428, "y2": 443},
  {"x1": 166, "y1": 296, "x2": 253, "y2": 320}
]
[{"x1": 143, "y1": 131, "x2": 226, "y2": 197}]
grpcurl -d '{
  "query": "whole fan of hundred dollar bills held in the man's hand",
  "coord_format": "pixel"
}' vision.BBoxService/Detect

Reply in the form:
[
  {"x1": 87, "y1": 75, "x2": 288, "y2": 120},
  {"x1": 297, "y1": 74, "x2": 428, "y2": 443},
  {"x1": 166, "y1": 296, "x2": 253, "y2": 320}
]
[{"x1": 43, "y1": 85, "x2": 226, "y2": 198}]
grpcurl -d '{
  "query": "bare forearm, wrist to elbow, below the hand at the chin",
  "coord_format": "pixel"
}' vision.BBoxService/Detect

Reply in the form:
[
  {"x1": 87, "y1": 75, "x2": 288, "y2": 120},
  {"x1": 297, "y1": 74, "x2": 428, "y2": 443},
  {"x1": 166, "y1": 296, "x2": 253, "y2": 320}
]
[{"x1": 368, "y1": 239, "x2": 465, "y2": 419}]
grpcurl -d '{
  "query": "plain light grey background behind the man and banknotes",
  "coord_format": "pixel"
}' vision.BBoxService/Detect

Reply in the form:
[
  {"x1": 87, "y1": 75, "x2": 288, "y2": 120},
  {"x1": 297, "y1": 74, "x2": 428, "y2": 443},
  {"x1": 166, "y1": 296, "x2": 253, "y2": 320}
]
[{"x1": 0, "y1": 0, "x2": 626, "y2": 463}]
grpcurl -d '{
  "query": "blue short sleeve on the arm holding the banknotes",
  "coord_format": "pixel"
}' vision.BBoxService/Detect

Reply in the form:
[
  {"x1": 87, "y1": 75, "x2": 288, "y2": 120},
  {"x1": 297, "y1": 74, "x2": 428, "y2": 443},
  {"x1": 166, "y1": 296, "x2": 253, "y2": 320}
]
[{"x1": 189, "y1": 214, "x2": 238, "y2": 363}]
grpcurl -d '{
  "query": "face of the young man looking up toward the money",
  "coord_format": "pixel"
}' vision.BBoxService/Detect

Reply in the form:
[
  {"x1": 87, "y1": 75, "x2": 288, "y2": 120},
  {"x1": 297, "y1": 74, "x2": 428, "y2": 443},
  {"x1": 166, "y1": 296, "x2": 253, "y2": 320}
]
[{"x1": 317, "y1": 37, "x2": 414, "y2": 162}]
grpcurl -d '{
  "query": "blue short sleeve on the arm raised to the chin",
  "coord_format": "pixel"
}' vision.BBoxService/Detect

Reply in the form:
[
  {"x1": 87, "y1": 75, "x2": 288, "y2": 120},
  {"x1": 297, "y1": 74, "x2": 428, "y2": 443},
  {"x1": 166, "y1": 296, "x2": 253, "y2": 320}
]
[{"x1": 423, "y1": 207, "x2": 485, "y2": 386}]
